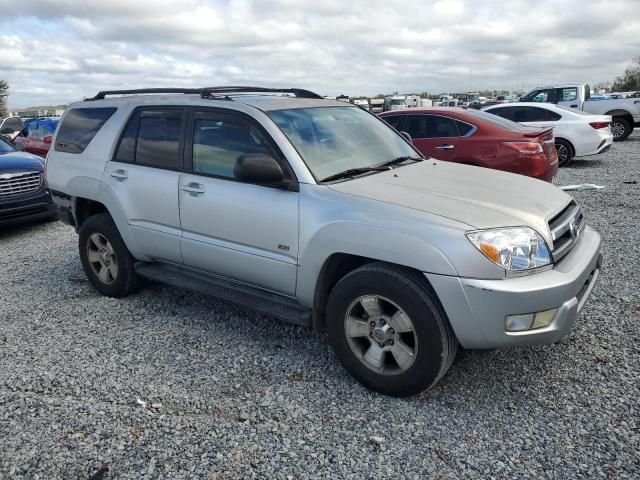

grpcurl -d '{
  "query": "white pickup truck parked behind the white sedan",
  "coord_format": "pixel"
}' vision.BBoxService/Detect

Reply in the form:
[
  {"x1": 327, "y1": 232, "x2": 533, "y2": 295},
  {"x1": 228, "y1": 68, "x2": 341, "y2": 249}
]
[{"x1": 520, "y1": 83, "x2": 640, "y2": 141}]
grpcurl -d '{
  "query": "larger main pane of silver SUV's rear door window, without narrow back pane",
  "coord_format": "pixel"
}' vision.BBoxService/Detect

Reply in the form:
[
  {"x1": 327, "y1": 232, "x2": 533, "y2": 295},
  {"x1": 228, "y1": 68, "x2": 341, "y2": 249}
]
[{"x1": 135, "y1": 110, "x2": 183, "y2": 169}]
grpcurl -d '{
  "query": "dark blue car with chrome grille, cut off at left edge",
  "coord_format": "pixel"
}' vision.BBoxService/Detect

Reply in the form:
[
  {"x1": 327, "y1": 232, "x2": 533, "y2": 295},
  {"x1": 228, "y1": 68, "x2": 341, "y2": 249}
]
[{"x1": 0, "y1": 138, "x2": 57, "y2": 225}]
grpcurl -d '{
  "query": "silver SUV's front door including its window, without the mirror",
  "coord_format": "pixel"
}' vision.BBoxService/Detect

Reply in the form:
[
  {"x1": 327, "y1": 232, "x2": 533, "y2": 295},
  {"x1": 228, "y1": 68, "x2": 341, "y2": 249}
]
[{"x1": 179, "y1": 109, "x2": 299, "y2": 295}]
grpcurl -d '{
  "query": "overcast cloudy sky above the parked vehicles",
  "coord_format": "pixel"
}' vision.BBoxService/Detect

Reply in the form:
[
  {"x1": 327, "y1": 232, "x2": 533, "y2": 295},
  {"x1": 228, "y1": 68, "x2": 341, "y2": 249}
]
[{"x1": 0, "y1": 0, "x2": 640, "y2": 107}]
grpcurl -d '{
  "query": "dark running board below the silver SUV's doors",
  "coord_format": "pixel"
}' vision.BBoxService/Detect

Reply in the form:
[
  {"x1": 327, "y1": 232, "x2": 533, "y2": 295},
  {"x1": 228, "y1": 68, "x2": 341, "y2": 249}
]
[{"x1": 134, "y1": 262, "x2": 311, "y2": 327}]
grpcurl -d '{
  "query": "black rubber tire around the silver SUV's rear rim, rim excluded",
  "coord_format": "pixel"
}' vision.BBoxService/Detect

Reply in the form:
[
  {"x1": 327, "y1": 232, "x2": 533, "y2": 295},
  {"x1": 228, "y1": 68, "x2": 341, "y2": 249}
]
[{"x1": 78, "y1": 213, "x2": 137, "y2": 298}]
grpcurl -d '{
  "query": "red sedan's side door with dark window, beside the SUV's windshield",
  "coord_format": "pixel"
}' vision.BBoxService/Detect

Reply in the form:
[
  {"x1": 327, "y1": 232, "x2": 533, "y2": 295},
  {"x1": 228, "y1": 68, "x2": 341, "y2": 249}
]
[{"x1": 404, "y1": 114, "x2": 460, "y2": 161}]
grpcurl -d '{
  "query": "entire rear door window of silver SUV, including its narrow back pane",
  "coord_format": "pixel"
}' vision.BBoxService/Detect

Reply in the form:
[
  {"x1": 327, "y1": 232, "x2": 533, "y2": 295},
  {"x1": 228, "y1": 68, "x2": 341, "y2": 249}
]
[{"x1": 114, "y1": 109, "x2": 184, "y2": 170}]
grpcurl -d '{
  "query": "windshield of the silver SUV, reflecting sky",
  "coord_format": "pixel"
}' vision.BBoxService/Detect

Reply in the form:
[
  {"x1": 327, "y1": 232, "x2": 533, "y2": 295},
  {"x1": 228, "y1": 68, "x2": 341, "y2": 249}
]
[{"x1": 267, "y1": 107, "x2": 421, "y2": 180}]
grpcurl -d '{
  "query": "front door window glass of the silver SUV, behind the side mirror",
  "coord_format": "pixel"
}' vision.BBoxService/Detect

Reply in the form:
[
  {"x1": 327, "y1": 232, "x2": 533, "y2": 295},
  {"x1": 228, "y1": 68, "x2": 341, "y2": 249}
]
[{"x1": 193, "y1": 114, "x2": 273, "y2": 178}]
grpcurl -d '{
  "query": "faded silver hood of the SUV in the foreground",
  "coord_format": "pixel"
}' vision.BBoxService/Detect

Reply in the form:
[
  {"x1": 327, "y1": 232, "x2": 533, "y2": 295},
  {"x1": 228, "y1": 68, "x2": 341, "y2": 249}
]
[{"x1": 329, "y1": 159, "x2": 571, "y2": 244}]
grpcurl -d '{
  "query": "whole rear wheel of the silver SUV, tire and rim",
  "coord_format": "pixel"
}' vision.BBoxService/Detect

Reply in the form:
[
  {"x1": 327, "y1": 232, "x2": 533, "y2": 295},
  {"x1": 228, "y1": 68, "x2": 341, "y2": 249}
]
[{"x1": 79, "y1": 213, "x2": 136, "y2": 297}]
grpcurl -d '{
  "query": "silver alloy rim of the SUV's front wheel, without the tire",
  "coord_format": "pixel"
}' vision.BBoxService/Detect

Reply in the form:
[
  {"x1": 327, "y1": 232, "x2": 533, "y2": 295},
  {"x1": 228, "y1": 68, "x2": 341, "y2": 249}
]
[{"x1": 344, "y1": 295, "x2": 418, "y2": 375}]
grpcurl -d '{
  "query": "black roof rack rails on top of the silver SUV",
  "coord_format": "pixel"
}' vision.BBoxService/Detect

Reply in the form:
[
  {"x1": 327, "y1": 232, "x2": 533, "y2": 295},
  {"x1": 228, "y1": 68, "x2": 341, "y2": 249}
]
[{"x1": 85, "y1": 86, "x2": 323, "y2": 102}]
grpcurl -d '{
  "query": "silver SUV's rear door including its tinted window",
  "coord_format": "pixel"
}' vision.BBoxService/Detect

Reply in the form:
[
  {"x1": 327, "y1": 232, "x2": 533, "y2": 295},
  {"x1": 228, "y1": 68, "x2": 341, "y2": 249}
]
[{"x1": 103, "y1": 107, "x2": 186, "y2": 263}]
